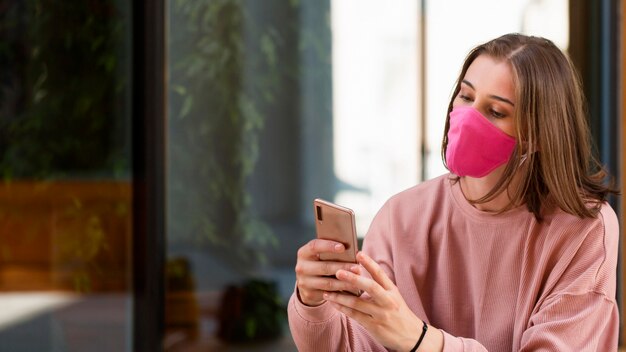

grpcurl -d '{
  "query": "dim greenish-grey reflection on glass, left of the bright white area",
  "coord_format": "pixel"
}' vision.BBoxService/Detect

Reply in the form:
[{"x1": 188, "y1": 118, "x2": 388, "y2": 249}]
[{"x1": 164, "y1": 0, "x2": 334, "y2": 351}]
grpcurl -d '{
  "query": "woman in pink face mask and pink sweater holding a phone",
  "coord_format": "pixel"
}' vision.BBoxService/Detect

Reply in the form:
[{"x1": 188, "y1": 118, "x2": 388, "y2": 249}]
[{"x1": 289, "y1": 34, "x2": 619, "y2": 351}]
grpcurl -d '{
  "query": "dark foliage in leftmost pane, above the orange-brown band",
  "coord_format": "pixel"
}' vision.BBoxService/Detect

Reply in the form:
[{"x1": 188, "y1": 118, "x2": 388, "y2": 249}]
[{"x1": 0, "y1": 0, "x2": 130, "y2": 180}]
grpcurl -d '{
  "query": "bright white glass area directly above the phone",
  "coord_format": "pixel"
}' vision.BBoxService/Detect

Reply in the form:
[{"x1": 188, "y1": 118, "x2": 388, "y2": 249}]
[{"x1": 330, "y1": 0, "x2": 421, "y2": 237}]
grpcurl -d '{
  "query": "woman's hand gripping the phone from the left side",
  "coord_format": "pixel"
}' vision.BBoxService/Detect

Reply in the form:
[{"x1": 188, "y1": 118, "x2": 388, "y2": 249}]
[{"x1": 296, "y1": 239, "x2": 358, "y2": 306}]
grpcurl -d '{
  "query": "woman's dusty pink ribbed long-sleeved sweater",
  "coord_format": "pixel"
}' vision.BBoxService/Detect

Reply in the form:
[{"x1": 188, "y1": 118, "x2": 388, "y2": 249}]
[{"x1": 288, "y1": 175, "x2": 619, "y2": 352}]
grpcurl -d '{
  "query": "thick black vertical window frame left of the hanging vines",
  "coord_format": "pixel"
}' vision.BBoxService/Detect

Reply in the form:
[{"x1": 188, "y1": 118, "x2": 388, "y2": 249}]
[{"x1": 132, "y1": 1, "x2": 166, "y2": 352}]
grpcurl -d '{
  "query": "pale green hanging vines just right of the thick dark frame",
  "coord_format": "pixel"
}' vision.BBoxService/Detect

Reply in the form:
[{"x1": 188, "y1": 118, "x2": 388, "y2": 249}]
[{"x1": 169, "y1": 0, "x2": 297, "y2": 268}]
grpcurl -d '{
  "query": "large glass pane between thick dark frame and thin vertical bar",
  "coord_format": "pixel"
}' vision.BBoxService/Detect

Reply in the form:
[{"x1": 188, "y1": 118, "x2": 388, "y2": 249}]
[{"x1": 164, "y1": 0, "x2": 420, "y2": 351}]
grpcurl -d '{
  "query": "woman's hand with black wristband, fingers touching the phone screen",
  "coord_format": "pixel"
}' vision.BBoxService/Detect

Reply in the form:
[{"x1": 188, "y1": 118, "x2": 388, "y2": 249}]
[{"x1": 324, "y1": 252, "x2": 423, "y2": 351}]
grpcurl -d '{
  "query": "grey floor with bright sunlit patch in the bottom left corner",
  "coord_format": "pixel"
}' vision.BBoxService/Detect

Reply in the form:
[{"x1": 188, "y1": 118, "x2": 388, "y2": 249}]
[{"x1": 0, "y1": 292, "x2": 131, "y2": 352}]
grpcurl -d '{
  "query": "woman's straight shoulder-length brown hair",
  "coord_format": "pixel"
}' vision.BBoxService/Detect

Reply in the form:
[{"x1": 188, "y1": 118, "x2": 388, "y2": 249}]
[{"x1": 442, "y1": 34, "x2": 617, "y2": 220}]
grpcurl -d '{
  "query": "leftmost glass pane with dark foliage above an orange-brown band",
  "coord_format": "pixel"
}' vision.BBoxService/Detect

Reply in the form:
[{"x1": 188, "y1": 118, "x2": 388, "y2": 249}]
[{"x1": 0, "y1": 0, "x2": 132, "y2": 351}]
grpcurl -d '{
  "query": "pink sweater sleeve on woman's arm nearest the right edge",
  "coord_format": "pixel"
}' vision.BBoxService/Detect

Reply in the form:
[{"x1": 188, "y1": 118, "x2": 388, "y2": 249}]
[{"x1": 444, "y1": 207, "x2": 619, "y2": 352}]
